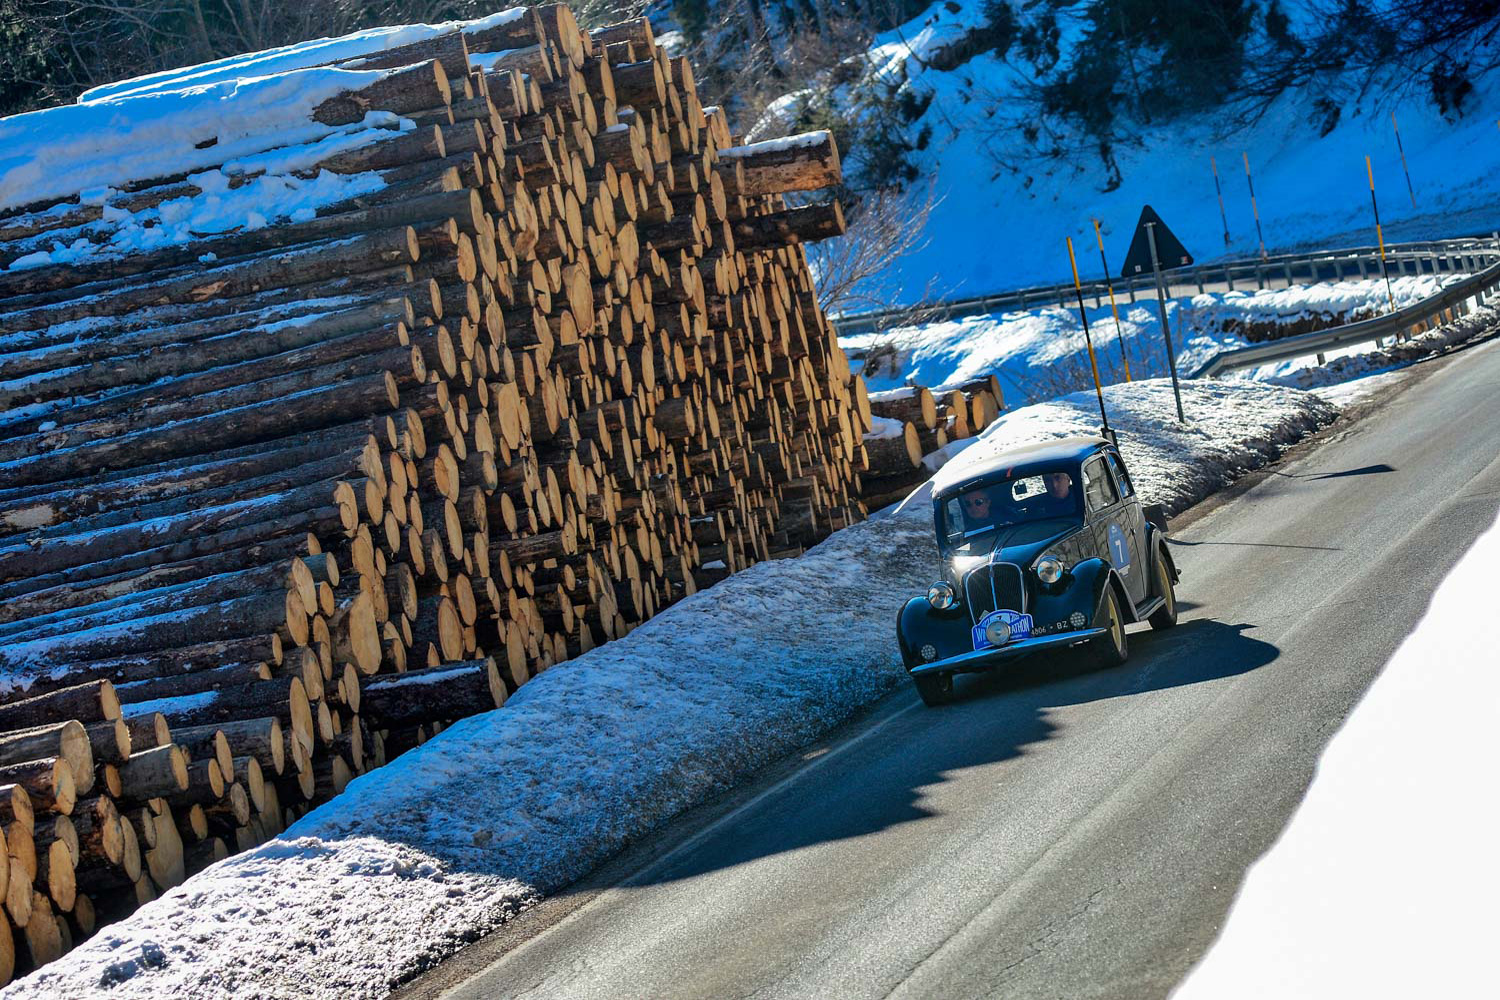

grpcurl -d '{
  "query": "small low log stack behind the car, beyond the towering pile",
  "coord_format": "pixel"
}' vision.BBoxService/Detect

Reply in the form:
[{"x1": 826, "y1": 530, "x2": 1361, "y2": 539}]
[{"x1": 860, "y1": 375, "x2": 1005, "y2": 510}]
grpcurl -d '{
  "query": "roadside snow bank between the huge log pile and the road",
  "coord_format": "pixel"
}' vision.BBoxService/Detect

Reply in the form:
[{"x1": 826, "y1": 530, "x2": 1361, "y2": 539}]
[{"x1": 0, "y1": 382, "x2": 1334, "y2": 1000}]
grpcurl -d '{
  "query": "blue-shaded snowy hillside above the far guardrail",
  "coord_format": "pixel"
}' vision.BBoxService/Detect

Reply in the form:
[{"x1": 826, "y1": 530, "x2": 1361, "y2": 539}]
[{"x1": 729, "y1": 0, "x2": 1500, "y2": 304}]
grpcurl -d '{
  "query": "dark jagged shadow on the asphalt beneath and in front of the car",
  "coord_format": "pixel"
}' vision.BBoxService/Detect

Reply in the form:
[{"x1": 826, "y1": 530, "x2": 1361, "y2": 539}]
[{"x1": 612, "y1": 618, "x2": 1280, "y2": 886}]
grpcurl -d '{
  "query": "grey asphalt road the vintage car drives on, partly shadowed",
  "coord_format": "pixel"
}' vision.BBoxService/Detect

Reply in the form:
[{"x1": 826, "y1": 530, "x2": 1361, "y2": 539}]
[{"x1": 402, "y1": 335, "x2": 1500, "y2": 1000}]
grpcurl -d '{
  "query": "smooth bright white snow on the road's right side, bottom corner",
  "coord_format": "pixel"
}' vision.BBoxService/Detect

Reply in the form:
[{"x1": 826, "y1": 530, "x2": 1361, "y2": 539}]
[{"x1": 1173, "y1": 509, "x2": 1500, "y2": 1000}]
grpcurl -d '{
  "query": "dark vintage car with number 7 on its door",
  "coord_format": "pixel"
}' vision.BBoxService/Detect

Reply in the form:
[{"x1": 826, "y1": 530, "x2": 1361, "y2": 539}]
[{"x1": 896, "y1": 438, "x2": 1178, "y2": 705}]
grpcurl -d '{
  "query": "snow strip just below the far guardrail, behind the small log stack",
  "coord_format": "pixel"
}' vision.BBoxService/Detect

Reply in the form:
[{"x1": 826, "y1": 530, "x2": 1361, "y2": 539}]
[{"x1": 839, "y1": 274, "x2": 1440, "y2": 406}]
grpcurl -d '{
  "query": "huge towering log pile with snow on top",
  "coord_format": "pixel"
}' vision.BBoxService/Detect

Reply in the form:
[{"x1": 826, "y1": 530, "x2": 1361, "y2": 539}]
[{"x1": 0, "y1": 4, "x2": 872, "y2": 982}]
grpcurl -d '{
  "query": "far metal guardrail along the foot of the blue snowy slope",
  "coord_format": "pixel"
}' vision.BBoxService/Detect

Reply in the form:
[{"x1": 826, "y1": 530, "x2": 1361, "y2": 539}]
[{"x1": 830, "y1": 234, "x2": 1500, "y2": 336}]
